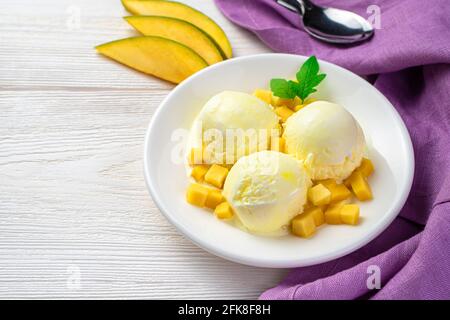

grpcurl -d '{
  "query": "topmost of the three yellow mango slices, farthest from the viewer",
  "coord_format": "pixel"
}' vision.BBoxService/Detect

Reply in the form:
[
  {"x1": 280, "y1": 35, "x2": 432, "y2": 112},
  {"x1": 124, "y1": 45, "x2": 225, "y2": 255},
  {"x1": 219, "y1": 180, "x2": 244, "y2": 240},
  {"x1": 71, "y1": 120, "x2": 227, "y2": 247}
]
[{"x1": 122, "y1": 0, "x2": 233, "y2": 59}]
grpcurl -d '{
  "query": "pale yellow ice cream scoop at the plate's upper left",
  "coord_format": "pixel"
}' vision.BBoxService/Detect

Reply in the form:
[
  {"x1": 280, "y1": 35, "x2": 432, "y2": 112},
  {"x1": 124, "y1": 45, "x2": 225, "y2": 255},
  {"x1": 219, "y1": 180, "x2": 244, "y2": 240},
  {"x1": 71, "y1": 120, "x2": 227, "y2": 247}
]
[{"x1": 189, "y1": 91, "x2": 278, "y2": 164}]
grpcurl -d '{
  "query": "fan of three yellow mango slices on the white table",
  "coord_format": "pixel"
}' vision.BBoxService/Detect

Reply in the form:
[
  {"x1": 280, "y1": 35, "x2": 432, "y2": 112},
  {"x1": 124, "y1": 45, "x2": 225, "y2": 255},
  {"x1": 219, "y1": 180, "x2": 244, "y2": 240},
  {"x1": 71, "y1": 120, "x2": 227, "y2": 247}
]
[{"x1": 96, "y1": 0, "x2": 232, "y2": 84}]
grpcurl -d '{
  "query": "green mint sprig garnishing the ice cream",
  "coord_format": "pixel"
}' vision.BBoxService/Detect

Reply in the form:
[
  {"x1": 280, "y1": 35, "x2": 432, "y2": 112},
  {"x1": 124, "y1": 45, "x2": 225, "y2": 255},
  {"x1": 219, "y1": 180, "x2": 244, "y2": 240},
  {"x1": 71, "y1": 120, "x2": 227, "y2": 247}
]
[{"x1": 270, "y1": 56, "x2": 326, "y2": 103}]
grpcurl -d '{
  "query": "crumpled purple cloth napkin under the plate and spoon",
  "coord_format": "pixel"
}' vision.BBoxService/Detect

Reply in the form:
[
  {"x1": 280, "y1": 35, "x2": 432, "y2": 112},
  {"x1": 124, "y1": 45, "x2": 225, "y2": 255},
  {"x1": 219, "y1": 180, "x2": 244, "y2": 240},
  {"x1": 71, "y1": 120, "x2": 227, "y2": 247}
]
[{"x1": 216, "y1": 0, "x2": 450, "y2": 299}]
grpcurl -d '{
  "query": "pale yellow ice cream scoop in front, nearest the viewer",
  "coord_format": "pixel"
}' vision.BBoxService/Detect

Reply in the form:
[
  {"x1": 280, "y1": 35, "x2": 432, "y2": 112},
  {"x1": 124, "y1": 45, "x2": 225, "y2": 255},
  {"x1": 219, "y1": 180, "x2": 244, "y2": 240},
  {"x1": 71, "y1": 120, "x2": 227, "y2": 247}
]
[{"x1": 223, "y1": 151, "x2": 311, "y2": 235}]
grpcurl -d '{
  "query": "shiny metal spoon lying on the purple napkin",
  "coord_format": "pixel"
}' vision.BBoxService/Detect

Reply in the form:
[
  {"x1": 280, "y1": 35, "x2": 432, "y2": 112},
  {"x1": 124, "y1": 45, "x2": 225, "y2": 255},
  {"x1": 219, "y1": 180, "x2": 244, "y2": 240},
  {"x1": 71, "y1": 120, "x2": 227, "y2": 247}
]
[{"x1": 276, "y1": 0, "x2": 374, "y2": 43}]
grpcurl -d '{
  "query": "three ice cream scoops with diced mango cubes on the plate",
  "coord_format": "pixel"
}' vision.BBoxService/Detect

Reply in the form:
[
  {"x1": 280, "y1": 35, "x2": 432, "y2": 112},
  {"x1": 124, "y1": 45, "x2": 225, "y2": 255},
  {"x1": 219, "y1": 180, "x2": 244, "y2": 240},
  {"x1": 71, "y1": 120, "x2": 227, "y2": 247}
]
[{"x1": 186, "y1": 90, "x2": 374, "y2": 237}]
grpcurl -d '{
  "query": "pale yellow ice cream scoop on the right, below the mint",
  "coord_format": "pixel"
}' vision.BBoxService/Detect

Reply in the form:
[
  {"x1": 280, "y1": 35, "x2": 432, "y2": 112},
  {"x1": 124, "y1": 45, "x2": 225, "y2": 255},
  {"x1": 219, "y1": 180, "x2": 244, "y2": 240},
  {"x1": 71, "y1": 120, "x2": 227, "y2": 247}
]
[{"x1": 283, "y1": 101, "x2": 365, "y2": 181}]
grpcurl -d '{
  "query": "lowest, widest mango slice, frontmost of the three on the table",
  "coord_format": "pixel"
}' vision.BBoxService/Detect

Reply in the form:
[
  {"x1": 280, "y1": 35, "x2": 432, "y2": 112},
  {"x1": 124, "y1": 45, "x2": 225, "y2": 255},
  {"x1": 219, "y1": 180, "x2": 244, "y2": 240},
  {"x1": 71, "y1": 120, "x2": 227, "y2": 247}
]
[{"x1": 96, "y1": 37, "x2": 208, "y2": 83}]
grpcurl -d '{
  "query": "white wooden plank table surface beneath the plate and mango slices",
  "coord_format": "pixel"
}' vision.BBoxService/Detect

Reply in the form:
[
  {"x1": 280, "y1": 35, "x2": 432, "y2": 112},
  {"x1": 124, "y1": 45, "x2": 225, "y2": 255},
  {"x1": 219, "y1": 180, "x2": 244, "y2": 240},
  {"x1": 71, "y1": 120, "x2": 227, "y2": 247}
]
[{"x1": 0, "y1": 0, "x2": 286, "y2": 299}]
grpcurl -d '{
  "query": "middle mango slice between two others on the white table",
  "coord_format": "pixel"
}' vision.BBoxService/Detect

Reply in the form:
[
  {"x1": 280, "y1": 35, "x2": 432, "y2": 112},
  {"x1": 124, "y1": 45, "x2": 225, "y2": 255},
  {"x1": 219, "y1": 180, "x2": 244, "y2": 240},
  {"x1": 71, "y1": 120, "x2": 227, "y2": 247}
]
[{"x1": 124, "y1": 16, "x2": 223, "y2": 65}]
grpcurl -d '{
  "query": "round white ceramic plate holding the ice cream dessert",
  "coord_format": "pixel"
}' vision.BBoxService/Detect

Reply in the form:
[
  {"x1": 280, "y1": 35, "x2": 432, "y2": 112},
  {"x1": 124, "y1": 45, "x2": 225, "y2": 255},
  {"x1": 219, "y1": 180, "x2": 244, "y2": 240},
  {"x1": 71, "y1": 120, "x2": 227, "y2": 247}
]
[{"x1": 144, "y1": 54, "x2": 414, "y2": 268}]
